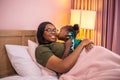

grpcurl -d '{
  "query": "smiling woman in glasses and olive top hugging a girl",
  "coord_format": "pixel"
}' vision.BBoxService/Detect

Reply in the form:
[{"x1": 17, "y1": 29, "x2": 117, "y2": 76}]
[{"x1": 36, "y1": 22, "x2": 93, "y2": 73}]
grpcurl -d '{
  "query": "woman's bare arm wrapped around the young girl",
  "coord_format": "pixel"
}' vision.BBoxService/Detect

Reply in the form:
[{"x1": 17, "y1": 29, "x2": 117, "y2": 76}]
[{"x1": 46, "y1": 39, "x2": 92, "y2": 73}]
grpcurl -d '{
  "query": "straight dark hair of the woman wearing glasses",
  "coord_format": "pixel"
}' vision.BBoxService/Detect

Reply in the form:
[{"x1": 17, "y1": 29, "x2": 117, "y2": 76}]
[{"x1": 37, "y1": 22, "x2": 54, "y2": 44}]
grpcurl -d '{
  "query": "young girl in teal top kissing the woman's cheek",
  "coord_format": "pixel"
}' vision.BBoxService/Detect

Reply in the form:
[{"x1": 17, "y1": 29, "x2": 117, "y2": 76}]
[{"x1": 58, "y1": 24, "x2": 92, "y2": 58}]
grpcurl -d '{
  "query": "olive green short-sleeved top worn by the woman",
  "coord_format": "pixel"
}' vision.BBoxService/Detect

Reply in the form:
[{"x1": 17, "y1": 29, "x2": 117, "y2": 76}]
[{"x1": 35, "y1": 42, "x2": 65, "y2": 66}]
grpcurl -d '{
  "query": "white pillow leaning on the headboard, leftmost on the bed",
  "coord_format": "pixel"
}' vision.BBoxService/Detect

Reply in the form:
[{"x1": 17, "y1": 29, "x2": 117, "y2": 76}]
[{"x1": 5, "y1": 44, "x2": 41, "y2": 77}]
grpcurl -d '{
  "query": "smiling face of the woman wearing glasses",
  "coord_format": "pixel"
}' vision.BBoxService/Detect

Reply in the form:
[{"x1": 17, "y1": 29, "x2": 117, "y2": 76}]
[{"x1": 43, "y1": 24, "x2": 57, "y2": 43}]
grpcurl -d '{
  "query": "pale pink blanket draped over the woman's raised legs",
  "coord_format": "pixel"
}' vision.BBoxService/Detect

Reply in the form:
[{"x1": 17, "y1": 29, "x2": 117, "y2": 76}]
[{"x1": 59, "y1": 46, "x2": 120, "y2": 80}]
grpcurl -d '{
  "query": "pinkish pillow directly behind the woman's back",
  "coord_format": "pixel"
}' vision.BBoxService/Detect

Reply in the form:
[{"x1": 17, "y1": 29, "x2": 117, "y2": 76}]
[{"x1": 28, "y1": 40, "x2": 57, "y2": 76}]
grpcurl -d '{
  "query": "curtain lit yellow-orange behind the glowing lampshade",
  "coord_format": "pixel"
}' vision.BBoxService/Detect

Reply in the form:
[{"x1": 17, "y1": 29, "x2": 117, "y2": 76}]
[{"x1": 71, "y1": 0, "x2": 102, "y2": 45}]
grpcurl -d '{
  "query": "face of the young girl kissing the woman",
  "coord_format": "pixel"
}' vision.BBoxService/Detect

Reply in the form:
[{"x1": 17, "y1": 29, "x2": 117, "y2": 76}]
[{"x1": 58, "y1": 28, "x2": 69, "y2": 40}]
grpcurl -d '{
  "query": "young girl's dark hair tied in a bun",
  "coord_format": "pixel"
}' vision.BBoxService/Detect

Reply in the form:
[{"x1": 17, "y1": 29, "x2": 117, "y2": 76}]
[{"x1": 63, "y1": 24, "x2": 79, "y2": 36}]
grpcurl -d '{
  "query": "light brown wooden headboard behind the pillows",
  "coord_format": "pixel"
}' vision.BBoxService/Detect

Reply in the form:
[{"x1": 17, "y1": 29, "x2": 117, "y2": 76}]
[{"x1": 0, "y1": 30, "x2": 37, "y2": 78}]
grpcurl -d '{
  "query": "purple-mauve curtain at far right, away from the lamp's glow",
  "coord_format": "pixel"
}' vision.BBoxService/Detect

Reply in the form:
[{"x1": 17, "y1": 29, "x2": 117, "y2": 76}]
[{"x1": 101, "y1": 0, "x2": 120, "y2": 54}]
